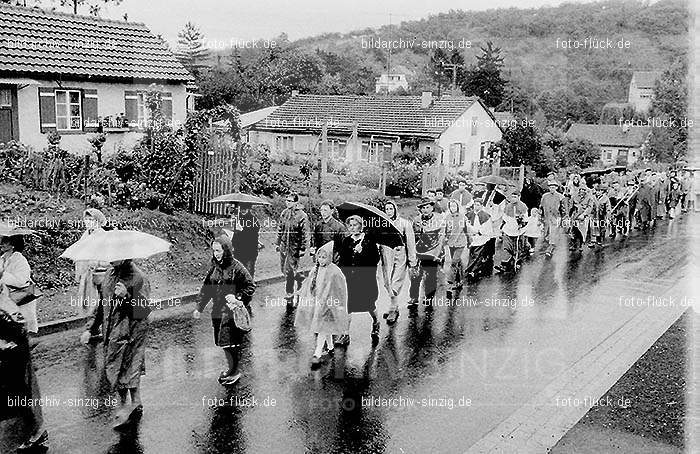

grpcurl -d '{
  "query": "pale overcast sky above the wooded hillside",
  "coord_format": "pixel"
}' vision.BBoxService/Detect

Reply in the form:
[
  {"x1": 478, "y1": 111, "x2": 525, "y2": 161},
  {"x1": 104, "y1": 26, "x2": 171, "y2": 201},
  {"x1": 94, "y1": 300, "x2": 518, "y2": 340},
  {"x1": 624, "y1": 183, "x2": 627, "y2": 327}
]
[{"x1": 90, "y1": 0, "x2": 600, "y2": 45}]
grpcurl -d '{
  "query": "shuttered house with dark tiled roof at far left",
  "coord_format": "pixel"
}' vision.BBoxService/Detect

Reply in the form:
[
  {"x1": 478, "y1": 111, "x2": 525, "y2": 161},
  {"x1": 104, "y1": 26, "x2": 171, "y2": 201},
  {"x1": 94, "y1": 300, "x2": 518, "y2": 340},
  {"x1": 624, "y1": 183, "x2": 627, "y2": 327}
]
[{"x1": 0, "y1": 5, "x2": 192, "y2": 153}]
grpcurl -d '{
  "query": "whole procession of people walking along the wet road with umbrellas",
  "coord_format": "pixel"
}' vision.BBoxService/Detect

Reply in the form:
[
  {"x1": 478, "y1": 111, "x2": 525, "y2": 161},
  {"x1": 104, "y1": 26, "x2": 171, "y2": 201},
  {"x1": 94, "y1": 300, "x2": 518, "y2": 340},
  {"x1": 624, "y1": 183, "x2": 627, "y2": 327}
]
[{"x1": 0, "y1": 169, "x2": 694, "y2": 448}]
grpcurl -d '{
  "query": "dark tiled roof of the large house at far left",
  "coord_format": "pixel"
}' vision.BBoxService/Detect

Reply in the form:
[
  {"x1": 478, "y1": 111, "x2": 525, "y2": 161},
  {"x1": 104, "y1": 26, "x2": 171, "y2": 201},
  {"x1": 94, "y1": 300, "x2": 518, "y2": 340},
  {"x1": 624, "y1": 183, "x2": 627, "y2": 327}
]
[{"x1": 0, "y1": 6, "x2": 192, "y2": 81}]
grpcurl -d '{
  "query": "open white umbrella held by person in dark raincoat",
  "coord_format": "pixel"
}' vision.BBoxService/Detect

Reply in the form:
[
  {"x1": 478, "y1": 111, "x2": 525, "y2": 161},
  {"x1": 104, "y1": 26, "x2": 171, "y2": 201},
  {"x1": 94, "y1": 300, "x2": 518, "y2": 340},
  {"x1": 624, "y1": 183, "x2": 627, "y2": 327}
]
[{"x1": 61, "y1": 230, "x2": 171, "y2": 262}]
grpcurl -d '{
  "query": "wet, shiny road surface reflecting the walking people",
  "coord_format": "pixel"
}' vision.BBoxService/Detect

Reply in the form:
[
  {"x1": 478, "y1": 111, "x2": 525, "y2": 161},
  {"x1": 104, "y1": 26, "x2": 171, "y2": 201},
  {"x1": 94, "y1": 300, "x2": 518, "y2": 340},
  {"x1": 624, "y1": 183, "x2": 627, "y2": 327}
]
[{"x1": 0, "y1": 215, "x2": 697, "y2": 454}]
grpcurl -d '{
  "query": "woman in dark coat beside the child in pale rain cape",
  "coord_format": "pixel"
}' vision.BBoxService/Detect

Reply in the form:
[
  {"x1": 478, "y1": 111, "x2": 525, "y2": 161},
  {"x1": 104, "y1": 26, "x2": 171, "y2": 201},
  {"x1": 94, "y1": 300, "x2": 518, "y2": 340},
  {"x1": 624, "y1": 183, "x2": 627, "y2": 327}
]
[{"x1": 338, "y1": 215, "x2": 379, "y2": 344}]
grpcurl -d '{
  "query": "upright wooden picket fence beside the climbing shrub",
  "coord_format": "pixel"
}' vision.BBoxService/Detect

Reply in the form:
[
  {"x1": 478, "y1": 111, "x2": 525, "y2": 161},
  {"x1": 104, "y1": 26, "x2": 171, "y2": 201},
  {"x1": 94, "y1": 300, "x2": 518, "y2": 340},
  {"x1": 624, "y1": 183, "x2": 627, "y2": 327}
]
[{"x1": 192, "y1": 133, "x2": 237, "y2": 216}]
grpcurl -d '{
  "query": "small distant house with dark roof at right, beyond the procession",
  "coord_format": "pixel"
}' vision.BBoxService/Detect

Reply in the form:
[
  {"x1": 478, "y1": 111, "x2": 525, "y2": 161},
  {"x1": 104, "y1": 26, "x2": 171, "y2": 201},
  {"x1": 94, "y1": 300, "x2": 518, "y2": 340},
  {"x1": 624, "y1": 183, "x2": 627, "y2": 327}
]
[{"x1": 566, "y1": 123, "x2": 651, "y2": 165}]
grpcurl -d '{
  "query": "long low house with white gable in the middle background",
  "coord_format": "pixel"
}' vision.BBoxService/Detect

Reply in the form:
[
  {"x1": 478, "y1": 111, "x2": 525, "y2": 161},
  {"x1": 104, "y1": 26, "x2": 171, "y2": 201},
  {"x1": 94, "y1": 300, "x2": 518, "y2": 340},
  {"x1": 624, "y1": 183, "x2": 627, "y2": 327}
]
[{"x1": 248, "y1": 92, "x2": 502, "y2": 170}]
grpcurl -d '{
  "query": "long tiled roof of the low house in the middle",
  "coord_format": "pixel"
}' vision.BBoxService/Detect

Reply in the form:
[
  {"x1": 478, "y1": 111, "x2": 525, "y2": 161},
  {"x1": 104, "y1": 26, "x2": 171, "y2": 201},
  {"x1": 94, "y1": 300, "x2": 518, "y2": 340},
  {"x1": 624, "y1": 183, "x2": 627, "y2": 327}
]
[{"x1": 253, "y1": 95, "x2": 486, "y2": 138}]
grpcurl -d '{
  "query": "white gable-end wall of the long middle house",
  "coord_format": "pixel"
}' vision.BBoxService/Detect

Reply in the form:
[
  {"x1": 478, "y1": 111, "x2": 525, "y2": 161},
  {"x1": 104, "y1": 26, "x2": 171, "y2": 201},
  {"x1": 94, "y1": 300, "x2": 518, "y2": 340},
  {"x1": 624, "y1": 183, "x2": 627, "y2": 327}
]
[{"x1": 438, "y1": 103, "x2": 503, "y2": 170}]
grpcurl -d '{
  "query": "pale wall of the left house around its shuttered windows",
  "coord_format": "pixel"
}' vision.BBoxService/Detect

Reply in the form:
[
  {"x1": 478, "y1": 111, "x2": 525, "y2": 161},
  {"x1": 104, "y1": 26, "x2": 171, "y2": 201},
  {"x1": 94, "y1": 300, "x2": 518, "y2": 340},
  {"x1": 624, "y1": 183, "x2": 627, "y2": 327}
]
[{"x1": 17, "y1": 81, "x2": 187, "y2": 154}]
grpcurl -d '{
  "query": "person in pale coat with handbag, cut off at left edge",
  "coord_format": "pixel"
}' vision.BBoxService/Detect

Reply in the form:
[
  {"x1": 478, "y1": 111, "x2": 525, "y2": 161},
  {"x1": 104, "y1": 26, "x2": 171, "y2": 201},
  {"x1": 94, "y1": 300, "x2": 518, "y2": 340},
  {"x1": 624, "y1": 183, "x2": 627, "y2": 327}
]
[{"x1": 0, "y1": 235, "x2": 39, "y2": 336}]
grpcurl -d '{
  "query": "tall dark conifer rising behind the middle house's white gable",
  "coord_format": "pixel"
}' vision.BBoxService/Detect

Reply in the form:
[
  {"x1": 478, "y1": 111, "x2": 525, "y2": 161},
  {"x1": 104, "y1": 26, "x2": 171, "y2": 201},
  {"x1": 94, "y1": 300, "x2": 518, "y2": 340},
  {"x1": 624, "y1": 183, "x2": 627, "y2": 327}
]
[{"x1": 462, "y1": 41, "x2": 507, "y2": 107}]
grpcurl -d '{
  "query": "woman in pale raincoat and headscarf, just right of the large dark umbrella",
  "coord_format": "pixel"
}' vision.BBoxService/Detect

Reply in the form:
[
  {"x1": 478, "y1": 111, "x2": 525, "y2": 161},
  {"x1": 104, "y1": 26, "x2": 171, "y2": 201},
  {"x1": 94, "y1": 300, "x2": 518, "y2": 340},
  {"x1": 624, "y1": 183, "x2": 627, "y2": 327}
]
[{"x1": 381, "y1": 201, "x2": 418, "y2": 325}]
